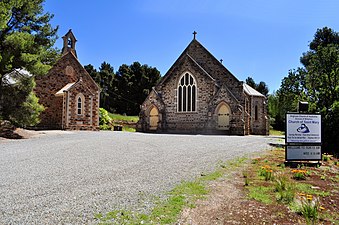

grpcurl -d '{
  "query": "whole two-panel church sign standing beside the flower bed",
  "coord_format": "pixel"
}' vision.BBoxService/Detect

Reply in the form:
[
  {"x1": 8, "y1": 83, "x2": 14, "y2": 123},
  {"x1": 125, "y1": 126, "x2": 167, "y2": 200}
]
[{"x1": 285, "y1": 113, "x2": 321, "y2": 161}]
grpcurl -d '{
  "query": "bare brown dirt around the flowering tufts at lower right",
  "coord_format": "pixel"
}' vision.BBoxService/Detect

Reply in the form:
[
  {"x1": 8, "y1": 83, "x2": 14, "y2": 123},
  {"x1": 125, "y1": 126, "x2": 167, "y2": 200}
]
[{"x1": 177, "y1": 149, "x2": 339, "y2": 225}]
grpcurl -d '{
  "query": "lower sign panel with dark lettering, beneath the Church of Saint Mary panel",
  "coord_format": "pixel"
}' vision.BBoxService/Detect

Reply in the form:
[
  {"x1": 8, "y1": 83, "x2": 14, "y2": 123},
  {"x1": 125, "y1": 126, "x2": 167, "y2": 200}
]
[{"x1": 286, "y1": 145, "x2": 321, "y2": 160}]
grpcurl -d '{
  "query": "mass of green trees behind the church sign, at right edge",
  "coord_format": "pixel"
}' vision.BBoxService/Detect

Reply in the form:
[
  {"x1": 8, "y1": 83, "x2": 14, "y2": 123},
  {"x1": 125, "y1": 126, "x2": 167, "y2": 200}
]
[{"x1": 269, "y1": 27, "x2": 339, "y2": 153}]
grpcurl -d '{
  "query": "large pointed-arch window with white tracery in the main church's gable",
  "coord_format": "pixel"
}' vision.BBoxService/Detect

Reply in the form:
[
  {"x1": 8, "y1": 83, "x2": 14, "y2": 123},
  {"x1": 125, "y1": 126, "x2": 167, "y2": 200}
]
[{"x1": 177, "y1": 72, "x2": 197, "y2": 112}]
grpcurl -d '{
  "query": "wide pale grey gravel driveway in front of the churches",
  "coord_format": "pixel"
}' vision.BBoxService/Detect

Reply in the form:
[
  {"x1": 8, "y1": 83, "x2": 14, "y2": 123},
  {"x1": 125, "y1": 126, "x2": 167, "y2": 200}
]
[{"x1": 0, "y1": 131, "x2": 273, "y2": 224}]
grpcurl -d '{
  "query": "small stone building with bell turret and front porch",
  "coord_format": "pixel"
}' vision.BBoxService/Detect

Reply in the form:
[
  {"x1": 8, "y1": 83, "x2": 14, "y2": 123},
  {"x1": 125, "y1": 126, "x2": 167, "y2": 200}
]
[{"x1": 35, "y1": 30, "x2": 100, "y2": 130}]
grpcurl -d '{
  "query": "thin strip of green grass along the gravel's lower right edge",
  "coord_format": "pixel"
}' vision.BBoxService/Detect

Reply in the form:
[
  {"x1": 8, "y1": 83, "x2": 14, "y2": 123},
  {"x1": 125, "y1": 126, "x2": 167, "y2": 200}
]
[{"x1": 95, "y1": 157, "x2": 250, "y2": 225}]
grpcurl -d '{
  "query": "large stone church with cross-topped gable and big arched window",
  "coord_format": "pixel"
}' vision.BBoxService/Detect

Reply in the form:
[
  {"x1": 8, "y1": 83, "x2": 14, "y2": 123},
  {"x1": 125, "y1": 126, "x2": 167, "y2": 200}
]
[{"x1": 137, "y1": 32, "x2": 269, "y2": 135}]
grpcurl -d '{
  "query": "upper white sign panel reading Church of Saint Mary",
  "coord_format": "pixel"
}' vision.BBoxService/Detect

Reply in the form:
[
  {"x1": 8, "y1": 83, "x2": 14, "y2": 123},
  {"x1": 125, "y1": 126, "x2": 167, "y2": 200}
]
[{"x1": 286, "y1": 114, "x2": 321, "y2": 143}]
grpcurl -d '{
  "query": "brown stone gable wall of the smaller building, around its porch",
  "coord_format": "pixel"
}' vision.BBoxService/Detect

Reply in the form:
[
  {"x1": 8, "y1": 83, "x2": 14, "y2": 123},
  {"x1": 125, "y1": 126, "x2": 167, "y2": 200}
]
[{"x1": 35, "y1": 52, "x2": 99, "y2": 130}]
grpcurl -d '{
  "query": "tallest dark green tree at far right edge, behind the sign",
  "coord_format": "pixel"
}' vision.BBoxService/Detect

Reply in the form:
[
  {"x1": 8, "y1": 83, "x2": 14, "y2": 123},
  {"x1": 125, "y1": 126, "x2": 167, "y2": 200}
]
[{"x1": 301, "y1": 27, "x2": 339, "y2": 154}]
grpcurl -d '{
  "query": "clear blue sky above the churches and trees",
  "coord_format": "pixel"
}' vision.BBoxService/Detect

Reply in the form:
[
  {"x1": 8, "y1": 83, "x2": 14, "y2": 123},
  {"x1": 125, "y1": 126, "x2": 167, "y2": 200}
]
[{"x1": 44, "y1": 0, "x2": 339, "y2": 92}]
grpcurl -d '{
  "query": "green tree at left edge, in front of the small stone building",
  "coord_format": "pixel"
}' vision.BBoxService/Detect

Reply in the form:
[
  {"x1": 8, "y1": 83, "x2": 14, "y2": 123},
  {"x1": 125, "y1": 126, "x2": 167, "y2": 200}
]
[{"x1": 0, "y1": 0, "x2": 58, "y2": 125}]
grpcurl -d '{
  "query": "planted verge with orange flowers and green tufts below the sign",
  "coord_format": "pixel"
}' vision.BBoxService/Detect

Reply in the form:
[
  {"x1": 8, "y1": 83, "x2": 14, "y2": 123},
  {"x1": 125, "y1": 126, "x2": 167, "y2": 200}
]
[{"x1": 244, "y1": 148, "x2": 339, "y2": 224}]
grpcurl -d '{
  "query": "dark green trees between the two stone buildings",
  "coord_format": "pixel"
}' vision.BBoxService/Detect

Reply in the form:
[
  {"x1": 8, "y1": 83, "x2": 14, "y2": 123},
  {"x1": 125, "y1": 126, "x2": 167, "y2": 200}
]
[{"x1": 84, "y1": 62, "x2": 160, "y2": 115}]
